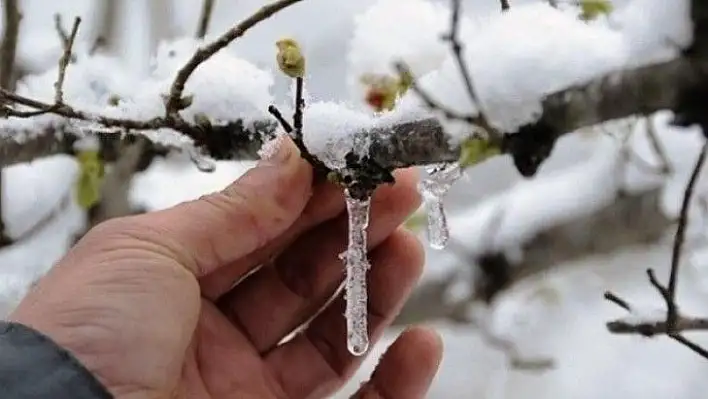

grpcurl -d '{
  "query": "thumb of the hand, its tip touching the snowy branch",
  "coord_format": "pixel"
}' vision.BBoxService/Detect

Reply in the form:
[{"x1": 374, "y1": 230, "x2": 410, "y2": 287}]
[{"x1": 112, "y1": 136, "x2": 312, "y2": 276}]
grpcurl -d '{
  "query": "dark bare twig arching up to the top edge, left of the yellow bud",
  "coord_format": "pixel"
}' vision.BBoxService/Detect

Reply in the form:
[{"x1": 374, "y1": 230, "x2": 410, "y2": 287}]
[{"x1": 165, "y1": 0, "x2": 302, "y2": 118}]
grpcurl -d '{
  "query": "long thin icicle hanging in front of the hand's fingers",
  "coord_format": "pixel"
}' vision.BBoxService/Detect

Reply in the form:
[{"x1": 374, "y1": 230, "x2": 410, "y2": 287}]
[{"x1": 339, "y1": 190, "x2": 371, "y2": 356}]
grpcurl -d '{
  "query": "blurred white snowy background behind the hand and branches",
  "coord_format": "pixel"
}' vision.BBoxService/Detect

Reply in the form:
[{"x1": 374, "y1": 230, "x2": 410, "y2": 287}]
[{"x1": 0, "y1": 0, "x2": 708, "y2": 399}]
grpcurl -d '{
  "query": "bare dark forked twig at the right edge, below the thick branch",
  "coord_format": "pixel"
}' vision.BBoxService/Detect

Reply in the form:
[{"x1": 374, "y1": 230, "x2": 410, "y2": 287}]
[{"x1": 605, "y1": 143, "x2": 708, "y2": 359}]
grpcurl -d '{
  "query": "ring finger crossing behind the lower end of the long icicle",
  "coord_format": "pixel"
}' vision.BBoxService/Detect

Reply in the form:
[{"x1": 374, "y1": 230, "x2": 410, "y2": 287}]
[{"x1": 265, "y1": 230, "x2": 424, "y2": 398}]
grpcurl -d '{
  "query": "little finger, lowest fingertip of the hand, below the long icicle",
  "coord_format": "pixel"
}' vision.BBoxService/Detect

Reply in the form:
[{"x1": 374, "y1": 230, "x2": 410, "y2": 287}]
[{"x1": 352, "y1": 327, "x2": 443, "y2": 399}]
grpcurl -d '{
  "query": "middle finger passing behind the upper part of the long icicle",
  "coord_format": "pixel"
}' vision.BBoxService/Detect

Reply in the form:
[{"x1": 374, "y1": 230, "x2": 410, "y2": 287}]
[{"x1": 219, "y1": 172, "x2": 420, "y2": 352}]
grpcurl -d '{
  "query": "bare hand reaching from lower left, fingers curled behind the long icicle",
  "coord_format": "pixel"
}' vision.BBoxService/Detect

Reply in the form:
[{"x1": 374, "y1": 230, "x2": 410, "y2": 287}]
[{"x1": 10, "y1": 139, "x2": 442, "y2": 399}]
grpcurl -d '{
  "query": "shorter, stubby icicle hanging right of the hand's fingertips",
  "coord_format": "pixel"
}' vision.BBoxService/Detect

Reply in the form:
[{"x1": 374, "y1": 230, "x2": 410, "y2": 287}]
[{"x1": 418, "y1": 163, "x2": 462, "y2": 249}]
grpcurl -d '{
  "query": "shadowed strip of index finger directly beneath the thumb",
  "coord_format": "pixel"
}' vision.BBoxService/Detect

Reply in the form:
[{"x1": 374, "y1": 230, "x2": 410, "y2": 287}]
[{"x1": 199, "y1": 180, "x2": 344, "y2": 301}]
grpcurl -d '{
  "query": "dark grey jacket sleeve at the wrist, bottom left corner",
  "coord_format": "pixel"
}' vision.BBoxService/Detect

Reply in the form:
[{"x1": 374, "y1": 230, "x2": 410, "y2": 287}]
[{"x1": 0, "y1": 321, "x2": 113, "y2": 399}]
